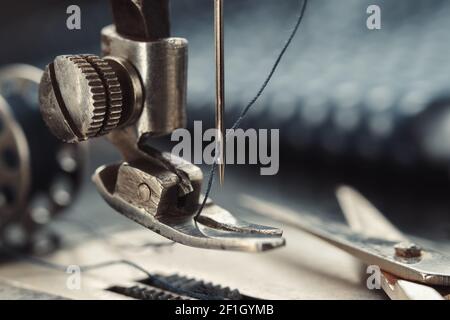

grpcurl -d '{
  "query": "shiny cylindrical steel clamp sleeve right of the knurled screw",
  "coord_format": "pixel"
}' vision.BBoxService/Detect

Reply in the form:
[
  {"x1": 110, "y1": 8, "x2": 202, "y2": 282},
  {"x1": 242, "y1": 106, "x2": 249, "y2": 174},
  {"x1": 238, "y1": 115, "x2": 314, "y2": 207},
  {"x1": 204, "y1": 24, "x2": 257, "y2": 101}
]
[{"x1": 102, "y1": 26, "x2": 188, "y2": 139}]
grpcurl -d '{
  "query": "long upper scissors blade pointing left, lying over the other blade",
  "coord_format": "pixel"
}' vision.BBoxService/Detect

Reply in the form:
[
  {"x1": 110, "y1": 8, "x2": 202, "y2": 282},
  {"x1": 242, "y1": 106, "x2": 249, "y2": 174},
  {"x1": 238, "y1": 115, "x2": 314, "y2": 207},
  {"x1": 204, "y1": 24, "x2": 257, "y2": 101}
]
[{"x1": 242, "y1": 196, "x2": 450, "y2": 286}]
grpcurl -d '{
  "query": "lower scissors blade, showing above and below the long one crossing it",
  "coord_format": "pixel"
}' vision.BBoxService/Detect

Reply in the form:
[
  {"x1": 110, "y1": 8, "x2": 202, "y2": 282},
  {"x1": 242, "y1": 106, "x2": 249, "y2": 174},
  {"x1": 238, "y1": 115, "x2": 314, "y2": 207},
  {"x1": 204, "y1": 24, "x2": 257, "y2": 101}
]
[{"x1": 336, "y1": 186, "x2": 443, "y2": 300}]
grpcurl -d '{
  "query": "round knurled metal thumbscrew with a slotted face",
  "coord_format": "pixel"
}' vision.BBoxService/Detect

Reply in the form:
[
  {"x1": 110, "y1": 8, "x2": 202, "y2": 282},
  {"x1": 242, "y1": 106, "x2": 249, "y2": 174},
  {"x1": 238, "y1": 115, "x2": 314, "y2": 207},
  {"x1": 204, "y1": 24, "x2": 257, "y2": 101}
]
[{"x1": 39, "y1": 55, "x2": 140, "y2": 142}]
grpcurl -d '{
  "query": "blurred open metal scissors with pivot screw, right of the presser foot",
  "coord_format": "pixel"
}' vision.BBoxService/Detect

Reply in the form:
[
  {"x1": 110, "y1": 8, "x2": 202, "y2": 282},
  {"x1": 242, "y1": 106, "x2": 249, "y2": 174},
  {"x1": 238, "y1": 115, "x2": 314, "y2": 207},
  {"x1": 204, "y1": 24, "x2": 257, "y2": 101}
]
[{"x1": 245, "y1": 186, "x2": 450, "y2": 300}]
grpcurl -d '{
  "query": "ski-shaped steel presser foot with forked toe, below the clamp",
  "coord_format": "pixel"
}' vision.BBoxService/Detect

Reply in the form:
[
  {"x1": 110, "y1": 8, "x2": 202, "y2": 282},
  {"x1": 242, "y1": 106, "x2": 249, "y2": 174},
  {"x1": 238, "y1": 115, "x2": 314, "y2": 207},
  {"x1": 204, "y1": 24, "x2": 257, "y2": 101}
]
[{"x1": 93, "y1": 161, "x2": 285, "y2": 252}]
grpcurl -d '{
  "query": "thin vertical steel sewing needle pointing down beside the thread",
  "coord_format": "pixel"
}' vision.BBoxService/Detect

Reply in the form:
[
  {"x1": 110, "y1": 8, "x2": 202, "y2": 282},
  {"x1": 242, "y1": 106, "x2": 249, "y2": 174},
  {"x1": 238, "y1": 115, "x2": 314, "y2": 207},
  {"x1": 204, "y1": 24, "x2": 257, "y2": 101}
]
[{"x1": 214, "y1": 0, "x2": 226, "y2": 185}]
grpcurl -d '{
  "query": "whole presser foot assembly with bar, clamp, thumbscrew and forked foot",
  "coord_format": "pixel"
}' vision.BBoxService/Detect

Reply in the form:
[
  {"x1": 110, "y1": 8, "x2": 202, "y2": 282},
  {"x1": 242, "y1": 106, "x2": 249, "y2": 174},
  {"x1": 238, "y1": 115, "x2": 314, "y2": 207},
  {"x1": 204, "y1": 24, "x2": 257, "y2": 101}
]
[{"x1": 40, "y1": 0, "x2": 285, "y2": 252}]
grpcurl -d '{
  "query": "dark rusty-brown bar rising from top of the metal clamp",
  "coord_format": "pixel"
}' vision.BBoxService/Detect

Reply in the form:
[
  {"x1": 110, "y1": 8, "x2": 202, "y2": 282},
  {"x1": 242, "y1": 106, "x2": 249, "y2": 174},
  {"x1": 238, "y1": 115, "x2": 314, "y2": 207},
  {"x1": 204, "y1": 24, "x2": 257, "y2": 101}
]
[{"x1": 111, "y1": 0, "x2": 170, "y2": 42}]
